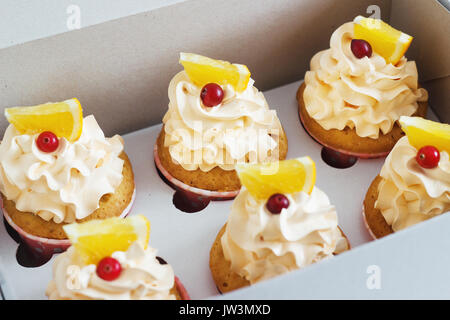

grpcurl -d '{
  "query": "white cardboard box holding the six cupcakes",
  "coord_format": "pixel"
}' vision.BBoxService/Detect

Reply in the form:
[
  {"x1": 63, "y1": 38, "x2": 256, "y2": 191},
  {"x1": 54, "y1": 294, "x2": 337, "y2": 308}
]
[{"x1": 0, "y1": 0, "x2": 450, "y2": 299}]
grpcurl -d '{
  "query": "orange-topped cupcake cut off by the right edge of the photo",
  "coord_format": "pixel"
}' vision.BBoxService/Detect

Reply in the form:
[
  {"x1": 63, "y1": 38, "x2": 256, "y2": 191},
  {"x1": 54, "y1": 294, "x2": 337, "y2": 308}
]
[{"x1": 363, "y1": 116, "x2": 450, "y2": 238}]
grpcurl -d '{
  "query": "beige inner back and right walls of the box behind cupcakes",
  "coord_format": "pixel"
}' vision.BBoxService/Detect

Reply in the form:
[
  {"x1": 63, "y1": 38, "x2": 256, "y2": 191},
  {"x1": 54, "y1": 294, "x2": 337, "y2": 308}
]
[{"x1": 0, "y1": 0, "x2": 450, "y2": 136}]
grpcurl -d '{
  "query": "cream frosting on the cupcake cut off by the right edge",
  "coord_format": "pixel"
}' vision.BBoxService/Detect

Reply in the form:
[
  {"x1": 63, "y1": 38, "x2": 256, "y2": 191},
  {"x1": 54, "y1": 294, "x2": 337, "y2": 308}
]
[{"x1": 375, "y1": 136, "x2": 450, "y2": 231}]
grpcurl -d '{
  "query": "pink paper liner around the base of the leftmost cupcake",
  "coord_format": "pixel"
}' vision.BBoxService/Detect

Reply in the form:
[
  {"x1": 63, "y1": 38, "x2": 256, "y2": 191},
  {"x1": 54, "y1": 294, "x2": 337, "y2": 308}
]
[{"x1": 0, "y1": 189, "x2": 136, "y2": 256}]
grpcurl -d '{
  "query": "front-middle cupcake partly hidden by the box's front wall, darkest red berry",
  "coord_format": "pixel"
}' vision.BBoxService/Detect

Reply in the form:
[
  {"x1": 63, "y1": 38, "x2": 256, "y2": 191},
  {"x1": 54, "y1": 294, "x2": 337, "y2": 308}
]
[{"x1": 210, "y1": 157, "x2": 350, "y2": 293}]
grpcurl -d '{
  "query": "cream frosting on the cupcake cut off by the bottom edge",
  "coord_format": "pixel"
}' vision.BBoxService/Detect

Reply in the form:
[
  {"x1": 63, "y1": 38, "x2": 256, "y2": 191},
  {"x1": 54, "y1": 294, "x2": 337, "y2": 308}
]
[{"x1": 46, "y1": 242, "x2": 176, "y2": 300}]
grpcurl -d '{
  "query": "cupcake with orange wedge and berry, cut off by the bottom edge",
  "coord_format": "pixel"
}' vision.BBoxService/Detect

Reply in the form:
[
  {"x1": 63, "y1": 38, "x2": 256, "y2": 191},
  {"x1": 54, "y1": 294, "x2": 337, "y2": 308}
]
[{"x1": 46, "y1": 215, "x2": 189, "y2": 300}]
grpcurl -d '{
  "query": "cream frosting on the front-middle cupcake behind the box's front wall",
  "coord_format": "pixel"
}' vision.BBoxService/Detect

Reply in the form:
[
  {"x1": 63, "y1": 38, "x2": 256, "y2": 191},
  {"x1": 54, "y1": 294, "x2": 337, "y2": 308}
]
[{"x1": 221, "y1": 187, "x2": 348, "y2": 283}]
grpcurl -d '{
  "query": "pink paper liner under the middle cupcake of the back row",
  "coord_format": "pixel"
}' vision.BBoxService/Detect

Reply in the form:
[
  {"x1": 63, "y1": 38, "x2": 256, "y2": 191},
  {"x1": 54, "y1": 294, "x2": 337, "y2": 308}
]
[{"x1": 153, "y1": 144, "x2": 239, "y2": 201}]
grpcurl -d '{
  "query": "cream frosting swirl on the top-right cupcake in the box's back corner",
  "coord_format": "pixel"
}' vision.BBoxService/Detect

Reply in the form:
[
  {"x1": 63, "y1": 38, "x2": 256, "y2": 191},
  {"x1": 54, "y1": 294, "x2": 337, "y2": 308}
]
[{"x1": 303, "y1": 22, "x2": 428, "y2": 139}]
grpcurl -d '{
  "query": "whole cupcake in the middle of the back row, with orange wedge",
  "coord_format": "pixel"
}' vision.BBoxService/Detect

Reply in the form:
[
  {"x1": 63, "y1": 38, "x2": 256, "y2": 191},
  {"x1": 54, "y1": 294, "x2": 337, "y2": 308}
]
[{"x1": 155, "y1": 53, "x2": 287, "y2": 198}]
